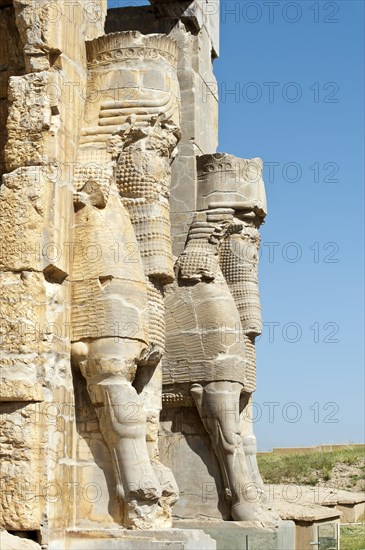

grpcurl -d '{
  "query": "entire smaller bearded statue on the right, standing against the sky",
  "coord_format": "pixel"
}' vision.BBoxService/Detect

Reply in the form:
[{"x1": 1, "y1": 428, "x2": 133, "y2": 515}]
[{"x1": 164, "y1": 153, "x2": 266, "y2": 521}]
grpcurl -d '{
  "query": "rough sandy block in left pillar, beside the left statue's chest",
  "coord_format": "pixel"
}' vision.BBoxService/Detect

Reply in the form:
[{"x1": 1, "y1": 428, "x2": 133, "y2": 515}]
[{"x1": 0, "y1": 166, "x2": 72, "y2": 276}]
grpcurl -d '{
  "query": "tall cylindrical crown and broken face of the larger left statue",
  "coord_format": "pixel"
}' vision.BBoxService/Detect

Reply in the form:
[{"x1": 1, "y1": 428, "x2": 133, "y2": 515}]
[{"x1": 85, "y1": 31, "x2": 180, "y2": 152}]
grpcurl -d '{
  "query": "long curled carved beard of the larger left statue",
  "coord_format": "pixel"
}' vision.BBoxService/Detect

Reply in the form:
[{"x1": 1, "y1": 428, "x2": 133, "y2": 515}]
[{"x1": 116, "y1": 125, "x2": 176, "y2": 283}]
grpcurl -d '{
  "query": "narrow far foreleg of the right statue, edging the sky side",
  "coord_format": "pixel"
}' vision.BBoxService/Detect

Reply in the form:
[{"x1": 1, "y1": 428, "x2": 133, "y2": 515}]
[{"x1": 241, "y1": 392, "x2": 267, "y2": 503}]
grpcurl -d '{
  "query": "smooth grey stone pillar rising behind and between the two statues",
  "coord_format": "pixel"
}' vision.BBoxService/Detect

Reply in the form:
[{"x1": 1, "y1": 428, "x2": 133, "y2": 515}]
[{"x1": 106, "y1": 0, "x2": 219, "y2": 255}]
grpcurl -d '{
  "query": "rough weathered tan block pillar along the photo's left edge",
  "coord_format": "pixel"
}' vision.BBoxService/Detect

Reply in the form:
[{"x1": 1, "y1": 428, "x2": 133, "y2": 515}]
[{"x1": 0, "y1": 0, "x2": 106, "y2": 547}]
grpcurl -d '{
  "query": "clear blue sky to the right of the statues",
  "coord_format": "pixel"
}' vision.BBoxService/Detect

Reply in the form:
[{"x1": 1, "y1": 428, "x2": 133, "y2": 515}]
[{"x1": 106, "y1": 0, "x2": 364, "y2": 450}]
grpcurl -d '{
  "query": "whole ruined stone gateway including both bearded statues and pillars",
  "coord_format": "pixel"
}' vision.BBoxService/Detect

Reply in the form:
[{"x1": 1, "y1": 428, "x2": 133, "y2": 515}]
[{"x1": 0, "y1": 0, "x2": 298, "y2": 550}]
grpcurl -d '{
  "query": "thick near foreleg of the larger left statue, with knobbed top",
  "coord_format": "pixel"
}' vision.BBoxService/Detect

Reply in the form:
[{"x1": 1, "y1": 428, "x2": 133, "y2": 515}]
[{"x1": 72, "y1": 338, "x2": 162, "y2": 529}]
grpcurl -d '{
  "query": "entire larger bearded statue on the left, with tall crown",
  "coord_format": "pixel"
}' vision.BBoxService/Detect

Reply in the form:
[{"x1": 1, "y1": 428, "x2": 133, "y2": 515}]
[{"x1": 72, "y1": 32, "x2": 180, "y2": 528}]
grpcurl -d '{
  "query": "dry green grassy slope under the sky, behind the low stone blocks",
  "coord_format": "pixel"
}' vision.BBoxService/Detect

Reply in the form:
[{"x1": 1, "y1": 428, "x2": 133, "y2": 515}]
[{"x1": 257, "y1": 446, "x2": 365, "y2": 485}]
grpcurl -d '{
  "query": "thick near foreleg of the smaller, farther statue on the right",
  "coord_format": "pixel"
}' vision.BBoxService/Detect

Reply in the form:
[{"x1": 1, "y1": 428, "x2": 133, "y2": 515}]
[{"x1": 191, "y1": 381, "x2": 262, "y2": 521}]
